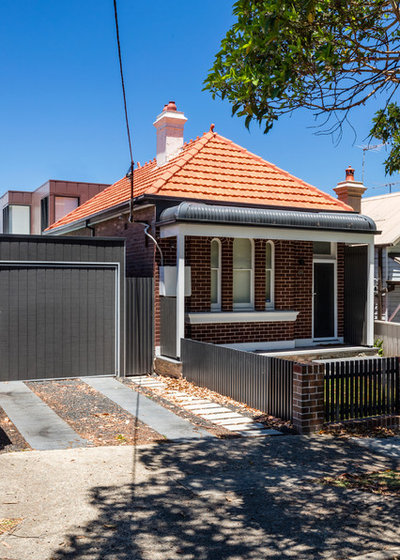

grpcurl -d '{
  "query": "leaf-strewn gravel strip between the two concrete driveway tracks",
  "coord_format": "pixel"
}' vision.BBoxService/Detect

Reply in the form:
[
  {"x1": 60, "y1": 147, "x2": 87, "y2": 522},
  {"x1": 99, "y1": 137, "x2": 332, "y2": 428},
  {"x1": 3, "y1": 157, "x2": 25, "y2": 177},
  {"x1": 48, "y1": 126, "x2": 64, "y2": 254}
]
[{"x1": 26, "y1": 379, "x2": 164, "y2": 446}]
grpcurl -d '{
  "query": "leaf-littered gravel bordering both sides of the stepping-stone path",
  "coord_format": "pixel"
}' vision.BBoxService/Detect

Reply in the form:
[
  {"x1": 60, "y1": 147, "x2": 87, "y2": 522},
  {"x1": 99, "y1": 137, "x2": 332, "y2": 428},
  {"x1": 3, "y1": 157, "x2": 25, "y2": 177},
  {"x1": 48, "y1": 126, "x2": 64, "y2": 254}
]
[{"x1": 124, "y1": 375, "x2": 294, "y2": 438}]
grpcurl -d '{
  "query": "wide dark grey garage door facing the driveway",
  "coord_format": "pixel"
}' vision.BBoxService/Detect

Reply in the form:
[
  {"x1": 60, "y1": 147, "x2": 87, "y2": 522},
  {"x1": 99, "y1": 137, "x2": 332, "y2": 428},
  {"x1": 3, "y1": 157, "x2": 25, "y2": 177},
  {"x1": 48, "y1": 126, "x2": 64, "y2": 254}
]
[{"x1": 0, "y1": 265, "x2": 116, "y2": 381}]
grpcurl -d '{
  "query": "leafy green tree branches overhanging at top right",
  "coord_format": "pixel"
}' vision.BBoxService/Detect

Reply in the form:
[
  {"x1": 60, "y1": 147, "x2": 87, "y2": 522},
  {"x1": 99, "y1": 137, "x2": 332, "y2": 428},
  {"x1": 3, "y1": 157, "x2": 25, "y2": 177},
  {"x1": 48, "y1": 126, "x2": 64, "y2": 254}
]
[{"x1": 204, "y1": 0, "x2": 400, "y2": 169}]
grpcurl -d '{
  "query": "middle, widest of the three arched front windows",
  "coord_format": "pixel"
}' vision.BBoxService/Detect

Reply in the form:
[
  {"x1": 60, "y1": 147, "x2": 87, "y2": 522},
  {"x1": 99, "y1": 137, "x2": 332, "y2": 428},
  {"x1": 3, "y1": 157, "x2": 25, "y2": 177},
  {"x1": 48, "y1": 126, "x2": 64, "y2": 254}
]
[{"x1": 233, "y1": 239, "x2": 254, "y2": 309}]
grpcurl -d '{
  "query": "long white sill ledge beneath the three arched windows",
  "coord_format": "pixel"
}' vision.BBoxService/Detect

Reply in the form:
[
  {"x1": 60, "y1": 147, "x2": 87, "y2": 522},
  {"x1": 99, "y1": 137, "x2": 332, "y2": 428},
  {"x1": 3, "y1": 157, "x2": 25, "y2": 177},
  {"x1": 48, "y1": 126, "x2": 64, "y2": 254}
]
[{"x1": 186, "y1": 310, "x2": 299, "y2": 325}]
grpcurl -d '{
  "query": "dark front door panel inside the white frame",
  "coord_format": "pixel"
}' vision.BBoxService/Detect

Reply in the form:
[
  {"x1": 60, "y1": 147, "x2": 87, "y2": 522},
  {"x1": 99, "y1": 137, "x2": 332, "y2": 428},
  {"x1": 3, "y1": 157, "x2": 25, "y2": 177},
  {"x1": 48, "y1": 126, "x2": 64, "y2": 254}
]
[{"x1": 313, "y1": 262, "x2": 335, "y2": 338}]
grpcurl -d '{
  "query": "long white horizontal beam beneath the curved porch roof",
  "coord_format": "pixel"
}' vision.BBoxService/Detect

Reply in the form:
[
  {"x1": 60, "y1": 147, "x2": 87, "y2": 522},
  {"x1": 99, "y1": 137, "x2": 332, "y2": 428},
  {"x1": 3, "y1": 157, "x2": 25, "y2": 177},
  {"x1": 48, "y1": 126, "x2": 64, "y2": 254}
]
[{"x1": 160, "y1": 223, "x2": 374, "y2": 245}]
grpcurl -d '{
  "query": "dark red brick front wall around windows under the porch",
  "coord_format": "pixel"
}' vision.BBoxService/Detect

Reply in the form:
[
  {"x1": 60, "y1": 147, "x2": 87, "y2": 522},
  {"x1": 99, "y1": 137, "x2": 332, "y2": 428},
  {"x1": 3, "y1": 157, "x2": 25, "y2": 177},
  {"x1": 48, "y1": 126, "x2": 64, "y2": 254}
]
[{"x1": 156, "y1": 237, "x2": 344, "y2": 344}]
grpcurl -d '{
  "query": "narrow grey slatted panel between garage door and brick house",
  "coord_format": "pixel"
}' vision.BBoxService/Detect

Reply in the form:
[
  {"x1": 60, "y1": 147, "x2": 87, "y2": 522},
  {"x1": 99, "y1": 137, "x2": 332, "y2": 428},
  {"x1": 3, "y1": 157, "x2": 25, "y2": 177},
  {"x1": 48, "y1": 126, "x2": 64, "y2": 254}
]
[{"x1": 126, "y1": 278, "x2": 154, "y2": 375}]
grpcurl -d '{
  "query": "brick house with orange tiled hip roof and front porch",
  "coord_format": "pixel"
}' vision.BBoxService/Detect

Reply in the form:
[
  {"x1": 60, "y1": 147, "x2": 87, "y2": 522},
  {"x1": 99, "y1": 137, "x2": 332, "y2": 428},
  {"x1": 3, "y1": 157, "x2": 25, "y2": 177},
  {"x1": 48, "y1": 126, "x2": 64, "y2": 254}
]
[{"x1": 47, "y1": 102, "x2": 375, "y2": 368}]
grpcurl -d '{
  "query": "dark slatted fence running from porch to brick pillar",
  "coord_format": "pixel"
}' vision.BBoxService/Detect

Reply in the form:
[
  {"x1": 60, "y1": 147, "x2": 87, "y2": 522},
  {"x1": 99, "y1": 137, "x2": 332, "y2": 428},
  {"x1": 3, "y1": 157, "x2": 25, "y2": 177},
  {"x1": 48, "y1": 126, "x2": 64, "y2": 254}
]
[{"x1": 181, "y1": 339, "x2": 293, "y2": 420}]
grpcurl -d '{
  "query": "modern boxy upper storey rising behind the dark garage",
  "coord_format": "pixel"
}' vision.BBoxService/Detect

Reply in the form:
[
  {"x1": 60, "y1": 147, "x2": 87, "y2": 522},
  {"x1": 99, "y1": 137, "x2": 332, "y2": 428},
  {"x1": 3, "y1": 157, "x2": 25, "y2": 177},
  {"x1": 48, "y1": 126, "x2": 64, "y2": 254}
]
[{"x1": 0, "y1": 179, "x2": 109, "y2": 234}]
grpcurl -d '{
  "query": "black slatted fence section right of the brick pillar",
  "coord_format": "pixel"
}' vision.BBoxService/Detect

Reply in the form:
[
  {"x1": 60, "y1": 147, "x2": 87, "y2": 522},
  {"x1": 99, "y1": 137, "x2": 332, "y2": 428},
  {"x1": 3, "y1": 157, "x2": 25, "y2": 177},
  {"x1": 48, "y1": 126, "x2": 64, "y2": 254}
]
[{"x1": 324, "y1": 358, "x2": 400, "y2": 422}]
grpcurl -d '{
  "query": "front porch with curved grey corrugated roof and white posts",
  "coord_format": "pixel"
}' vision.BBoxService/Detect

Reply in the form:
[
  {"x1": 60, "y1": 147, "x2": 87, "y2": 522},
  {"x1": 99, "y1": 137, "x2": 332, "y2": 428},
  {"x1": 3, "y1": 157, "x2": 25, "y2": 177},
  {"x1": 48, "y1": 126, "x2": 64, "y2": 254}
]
[{"x1": 156, "y1": 203, "x2": 376, "y2": 360}]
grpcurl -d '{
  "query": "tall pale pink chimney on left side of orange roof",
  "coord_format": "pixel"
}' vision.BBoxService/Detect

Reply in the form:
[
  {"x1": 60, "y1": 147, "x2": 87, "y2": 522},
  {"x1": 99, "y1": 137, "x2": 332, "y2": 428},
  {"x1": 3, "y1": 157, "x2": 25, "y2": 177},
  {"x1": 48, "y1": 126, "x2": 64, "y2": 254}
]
[{"x1": 153, "y1": 101, "x2": 187, "y2": 166}]
